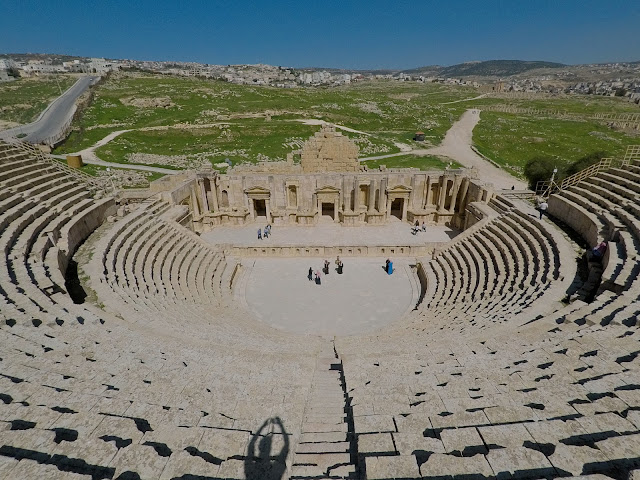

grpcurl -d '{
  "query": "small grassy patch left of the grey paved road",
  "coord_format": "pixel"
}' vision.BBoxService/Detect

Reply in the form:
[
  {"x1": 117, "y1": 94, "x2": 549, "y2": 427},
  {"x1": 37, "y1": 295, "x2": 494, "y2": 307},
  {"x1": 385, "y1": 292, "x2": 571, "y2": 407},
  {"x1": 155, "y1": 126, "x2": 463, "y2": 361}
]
[{"x1": 0, "y1": 75, "x2": 77, "y2": 124}]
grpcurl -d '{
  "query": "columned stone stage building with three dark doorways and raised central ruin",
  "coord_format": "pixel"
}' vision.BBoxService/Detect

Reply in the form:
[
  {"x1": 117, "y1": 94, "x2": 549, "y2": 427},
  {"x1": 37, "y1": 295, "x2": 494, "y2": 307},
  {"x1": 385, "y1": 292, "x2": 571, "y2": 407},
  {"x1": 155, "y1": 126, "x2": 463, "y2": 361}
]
[{"x1": 165, "y1": 127, "x2": 492, "y2": 231}]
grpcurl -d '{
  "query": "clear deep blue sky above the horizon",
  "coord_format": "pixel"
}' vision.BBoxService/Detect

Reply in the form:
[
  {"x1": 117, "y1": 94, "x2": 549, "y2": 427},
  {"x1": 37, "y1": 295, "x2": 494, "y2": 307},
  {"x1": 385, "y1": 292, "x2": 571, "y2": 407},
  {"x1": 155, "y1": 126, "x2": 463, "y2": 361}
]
[{"x1": 0, "y1": 0, "x2": 640, "y2": 69}]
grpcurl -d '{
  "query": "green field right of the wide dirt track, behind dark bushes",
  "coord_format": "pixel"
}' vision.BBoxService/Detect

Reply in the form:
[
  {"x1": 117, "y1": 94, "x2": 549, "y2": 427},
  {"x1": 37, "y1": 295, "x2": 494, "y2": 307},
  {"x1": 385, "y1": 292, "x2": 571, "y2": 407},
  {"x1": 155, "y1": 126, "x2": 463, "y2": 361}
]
[{"x1": 473, "y1": 112, "x2": 640, "y2": 175}]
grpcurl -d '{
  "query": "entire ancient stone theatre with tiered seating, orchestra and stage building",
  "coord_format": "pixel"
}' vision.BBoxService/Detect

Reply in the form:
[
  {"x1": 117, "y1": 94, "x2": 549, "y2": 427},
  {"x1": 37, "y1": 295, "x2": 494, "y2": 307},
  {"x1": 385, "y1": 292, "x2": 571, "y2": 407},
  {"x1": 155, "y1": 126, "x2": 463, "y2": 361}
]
[{"x1": 0, "y1": 126, "x2": 640, "y2": 480}]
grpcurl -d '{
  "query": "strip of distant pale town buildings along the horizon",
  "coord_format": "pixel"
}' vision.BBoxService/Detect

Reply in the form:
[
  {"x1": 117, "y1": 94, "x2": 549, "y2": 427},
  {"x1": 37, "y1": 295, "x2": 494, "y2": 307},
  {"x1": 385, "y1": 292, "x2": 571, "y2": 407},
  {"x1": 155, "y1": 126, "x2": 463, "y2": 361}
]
[{"x1": 0, "y1": 54, "x2": 640, "y2": 103}]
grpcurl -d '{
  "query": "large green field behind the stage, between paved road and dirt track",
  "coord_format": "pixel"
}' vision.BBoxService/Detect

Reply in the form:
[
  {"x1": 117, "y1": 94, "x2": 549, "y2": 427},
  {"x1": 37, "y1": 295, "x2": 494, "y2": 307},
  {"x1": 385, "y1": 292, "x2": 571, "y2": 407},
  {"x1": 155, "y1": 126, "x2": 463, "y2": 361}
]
[{"x1": 57, "y1": 75, "x2": 475, "y2": 168}]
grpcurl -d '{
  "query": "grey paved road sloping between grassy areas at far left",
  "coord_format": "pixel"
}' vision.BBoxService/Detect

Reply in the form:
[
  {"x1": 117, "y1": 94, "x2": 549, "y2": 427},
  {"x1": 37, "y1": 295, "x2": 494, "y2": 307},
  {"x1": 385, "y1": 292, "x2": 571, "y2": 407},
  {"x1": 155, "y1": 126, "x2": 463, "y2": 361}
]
[{"x1": 0, "y1": 77, "x2": 100, "y2": 143}]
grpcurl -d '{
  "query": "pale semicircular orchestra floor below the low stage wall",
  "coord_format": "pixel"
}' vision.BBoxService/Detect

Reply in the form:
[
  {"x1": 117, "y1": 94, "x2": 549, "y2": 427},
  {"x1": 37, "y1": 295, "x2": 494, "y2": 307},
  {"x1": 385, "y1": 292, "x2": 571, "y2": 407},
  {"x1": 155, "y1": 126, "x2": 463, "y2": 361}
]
[{"x1": 236, "y1": 257, "x2": 419, "y2": 336}]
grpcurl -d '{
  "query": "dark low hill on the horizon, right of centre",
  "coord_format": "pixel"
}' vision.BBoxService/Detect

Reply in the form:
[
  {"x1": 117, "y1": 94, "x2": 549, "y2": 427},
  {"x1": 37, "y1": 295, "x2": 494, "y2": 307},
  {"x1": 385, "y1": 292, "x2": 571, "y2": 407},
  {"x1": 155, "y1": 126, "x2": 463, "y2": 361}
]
[{"x1": 403, "y1": 60, "x2": 566, "y2": 77}]
